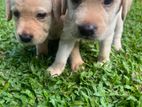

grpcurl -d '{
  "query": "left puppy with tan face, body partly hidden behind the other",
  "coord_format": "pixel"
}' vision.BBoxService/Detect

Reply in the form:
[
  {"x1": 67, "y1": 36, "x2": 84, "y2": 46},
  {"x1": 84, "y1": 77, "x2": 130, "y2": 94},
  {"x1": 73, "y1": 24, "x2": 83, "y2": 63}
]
[{"x1": 6, "y1": 0, "x2": 63, "y2": 55}]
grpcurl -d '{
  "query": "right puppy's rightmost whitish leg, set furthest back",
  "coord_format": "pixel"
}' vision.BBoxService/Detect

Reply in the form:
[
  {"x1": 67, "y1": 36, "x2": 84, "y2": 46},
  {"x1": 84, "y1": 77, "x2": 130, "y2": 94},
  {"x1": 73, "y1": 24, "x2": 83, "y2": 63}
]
[{"x1": 113, "y1": 11, "x2": 124, "y2": 51}]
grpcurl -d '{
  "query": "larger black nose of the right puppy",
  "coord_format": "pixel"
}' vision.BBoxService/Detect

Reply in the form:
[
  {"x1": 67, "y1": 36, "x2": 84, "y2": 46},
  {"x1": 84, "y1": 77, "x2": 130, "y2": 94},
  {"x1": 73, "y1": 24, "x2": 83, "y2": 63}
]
[{"x1": 78, "y1": 25, "x2": 97, "y2": 36}]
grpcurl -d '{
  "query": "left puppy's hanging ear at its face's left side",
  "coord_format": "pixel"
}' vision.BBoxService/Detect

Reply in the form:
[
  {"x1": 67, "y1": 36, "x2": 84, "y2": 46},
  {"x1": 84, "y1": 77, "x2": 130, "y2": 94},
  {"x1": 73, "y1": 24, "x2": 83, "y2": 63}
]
[{"x1": 5, "y1": 0, "x2": 12, "y2": 21}]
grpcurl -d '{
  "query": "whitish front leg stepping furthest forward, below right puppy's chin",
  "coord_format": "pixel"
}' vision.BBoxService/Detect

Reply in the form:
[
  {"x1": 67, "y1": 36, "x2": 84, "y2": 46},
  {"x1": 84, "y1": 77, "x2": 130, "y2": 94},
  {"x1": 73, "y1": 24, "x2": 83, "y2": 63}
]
[{"x1": 47, "y1": 36, "x2": 76, "y2": 76}]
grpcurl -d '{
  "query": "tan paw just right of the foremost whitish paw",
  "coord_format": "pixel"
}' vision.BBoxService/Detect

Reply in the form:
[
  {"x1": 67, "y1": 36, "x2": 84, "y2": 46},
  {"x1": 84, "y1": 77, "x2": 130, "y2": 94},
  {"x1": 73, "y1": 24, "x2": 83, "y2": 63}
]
[{"x1": 71, "y1": 59, "x2": 84, "y2": 72}]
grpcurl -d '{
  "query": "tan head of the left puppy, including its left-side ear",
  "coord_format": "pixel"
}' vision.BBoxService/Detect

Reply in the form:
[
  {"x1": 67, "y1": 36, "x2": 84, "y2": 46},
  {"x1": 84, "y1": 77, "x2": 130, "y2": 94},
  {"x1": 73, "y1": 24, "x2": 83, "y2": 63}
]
[{"x1": 6, "y1": 0, "x2": 52, "y2": 44}]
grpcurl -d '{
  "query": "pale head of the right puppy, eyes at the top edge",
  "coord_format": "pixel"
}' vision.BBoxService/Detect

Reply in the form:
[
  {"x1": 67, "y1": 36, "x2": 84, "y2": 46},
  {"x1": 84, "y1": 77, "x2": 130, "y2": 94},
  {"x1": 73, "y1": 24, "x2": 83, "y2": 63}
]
[{"x1": 67, "y1": 0, "x2": 130, "y2": 40}]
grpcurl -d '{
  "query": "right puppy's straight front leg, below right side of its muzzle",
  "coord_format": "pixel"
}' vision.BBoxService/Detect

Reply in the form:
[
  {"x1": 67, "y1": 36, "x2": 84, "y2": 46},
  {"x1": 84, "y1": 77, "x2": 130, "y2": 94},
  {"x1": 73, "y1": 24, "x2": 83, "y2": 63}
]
[{"x1": 98, "y1": 33, "x2": 114, "y2": 63}]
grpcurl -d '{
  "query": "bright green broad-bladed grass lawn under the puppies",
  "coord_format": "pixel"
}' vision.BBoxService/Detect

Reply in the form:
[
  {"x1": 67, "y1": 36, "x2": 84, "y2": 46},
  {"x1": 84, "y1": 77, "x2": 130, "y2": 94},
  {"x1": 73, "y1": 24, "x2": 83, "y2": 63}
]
[{"x1": 0, "y1": 0, "x2": 142, "y2": 107}]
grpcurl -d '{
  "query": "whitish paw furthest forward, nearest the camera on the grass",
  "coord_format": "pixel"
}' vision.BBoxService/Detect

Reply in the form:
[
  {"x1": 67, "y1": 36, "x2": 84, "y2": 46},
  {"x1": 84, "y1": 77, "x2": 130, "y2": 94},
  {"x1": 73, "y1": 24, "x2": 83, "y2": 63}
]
[{"x1": 47, "y1": 63, "x2": 65, "y2": 77}]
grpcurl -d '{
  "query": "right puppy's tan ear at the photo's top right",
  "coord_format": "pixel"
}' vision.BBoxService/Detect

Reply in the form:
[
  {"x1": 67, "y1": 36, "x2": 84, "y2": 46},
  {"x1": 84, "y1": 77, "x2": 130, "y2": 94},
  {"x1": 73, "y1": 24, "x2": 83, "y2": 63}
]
[{"x1": 122, "y1": 0, "x2": 132, "y2": 20}]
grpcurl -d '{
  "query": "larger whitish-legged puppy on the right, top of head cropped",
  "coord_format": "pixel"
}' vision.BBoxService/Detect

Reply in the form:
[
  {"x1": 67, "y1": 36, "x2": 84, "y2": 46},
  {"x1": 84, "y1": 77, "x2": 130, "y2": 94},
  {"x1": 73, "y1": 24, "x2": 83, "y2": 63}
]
[{"x1": 48, "y1": 0, "x2": 132, "y2": 75}]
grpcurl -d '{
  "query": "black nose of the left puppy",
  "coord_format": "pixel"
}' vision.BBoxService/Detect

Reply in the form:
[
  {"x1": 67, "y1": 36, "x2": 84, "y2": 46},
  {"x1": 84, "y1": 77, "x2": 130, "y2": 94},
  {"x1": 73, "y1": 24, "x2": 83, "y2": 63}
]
[{"x1": 19, "y1": 33, "x2": 33, "y2": 43}]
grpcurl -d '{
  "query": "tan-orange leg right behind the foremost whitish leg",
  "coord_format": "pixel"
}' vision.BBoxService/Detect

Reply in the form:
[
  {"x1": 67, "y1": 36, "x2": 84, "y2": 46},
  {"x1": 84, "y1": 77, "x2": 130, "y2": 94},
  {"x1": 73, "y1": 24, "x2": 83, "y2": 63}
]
[{"x1": 70, "y1": 41, "x2": 84, "y2": 71}]
